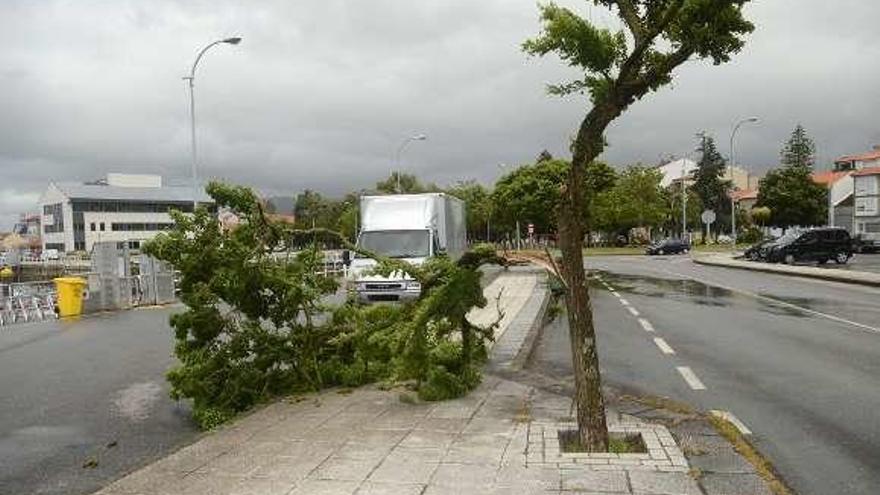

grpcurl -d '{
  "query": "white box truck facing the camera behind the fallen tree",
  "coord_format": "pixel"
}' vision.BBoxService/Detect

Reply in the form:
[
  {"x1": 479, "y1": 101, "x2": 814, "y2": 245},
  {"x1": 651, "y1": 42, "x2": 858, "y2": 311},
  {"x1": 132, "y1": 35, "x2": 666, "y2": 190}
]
[{"x1": 345, "y1": 193, "x2": 467, "y2": 302}]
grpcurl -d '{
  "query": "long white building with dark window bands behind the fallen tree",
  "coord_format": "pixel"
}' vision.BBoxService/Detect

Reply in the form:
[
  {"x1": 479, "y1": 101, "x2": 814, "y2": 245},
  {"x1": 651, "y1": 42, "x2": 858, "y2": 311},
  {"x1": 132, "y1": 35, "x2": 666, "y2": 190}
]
[{"x1": 40, "y1": 174, "x2": 212, "y2": 252}]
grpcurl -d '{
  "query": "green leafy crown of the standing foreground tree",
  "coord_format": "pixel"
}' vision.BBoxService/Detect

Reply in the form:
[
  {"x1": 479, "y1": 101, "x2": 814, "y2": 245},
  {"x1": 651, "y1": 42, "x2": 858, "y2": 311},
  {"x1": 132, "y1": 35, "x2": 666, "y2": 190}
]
[{"x1": 522, "y1": 0, "x2": 754, "y2": 105}]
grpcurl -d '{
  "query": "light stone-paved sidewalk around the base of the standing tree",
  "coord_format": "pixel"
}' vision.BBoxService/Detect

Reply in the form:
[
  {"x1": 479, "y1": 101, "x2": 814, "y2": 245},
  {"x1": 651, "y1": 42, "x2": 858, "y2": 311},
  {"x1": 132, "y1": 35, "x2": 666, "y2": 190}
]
[{"x1": 99, "y1": 269, "x2": 701, "y2": 495}]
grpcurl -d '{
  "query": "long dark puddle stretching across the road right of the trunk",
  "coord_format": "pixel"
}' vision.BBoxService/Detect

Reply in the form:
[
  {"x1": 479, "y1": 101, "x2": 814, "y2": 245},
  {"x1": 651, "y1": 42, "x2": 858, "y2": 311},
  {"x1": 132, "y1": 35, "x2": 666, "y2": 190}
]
[{"x1": 592, "y1": 270, "x2": 817, "y2": 318}]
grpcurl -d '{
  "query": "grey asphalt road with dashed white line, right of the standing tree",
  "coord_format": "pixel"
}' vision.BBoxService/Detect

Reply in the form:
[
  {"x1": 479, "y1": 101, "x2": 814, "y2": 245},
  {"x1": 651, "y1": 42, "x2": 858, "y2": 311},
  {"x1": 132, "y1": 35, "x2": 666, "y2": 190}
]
[{"x1": 531, "y1": 256, "x2": 880, "y2": 495}]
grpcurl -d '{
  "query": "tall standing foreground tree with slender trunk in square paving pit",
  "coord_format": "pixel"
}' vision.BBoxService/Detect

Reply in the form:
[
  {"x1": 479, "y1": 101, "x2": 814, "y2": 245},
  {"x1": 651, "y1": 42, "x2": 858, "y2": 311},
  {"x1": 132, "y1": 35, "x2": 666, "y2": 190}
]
[{"x1": 523, "y1": 0, "x2": 754, "y2": 451}]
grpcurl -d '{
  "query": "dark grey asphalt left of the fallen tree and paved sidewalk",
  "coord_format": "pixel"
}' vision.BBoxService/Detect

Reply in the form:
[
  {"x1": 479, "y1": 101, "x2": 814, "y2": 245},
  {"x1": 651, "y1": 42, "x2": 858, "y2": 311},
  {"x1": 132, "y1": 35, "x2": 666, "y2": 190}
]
[{"x1": 0, "y1": 309, "x2": 198, "y2": 494}]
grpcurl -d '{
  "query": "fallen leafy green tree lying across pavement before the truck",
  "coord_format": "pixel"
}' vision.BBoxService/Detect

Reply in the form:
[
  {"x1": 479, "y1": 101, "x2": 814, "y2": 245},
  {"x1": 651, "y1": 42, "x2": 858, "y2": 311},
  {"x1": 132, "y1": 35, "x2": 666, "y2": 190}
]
[{"x1": 145, "y1": 183, "x2": 504, "y2": 428}]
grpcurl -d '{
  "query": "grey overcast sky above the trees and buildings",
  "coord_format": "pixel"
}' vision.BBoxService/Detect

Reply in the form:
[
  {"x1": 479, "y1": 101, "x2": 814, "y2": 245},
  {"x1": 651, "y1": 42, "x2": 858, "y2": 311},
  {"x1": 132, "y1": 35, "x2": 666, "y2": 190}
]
[{"x1": 0, "y1": 0, "x2": 880, "y2": 230}]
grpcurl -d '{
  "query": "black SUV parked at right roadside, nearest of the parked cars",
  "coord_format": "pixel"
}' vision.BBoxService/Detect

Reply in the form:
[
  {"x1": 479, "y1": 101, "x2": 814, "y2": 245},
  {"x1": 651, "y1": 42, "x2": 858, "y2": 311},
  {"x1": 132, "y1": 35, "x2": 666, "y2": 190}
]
[{"x1": 767, "y1": 227, "x2": 852, "y2": 265}]
